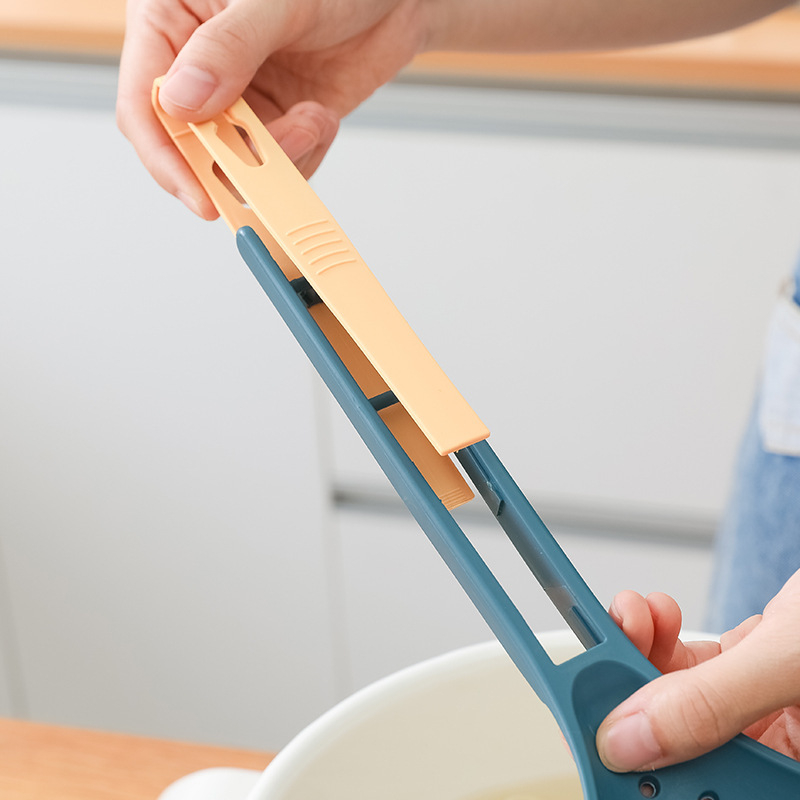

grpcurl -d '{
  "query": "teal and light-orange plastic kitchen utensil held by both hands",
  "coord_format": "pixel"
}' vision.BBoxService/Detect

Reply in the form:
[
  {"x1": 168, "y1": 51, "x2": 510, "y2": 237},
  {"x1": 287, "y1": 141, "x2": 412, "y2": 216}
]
[{"x1": 153, "y1": 81, "x2": 800, "y2": 800}]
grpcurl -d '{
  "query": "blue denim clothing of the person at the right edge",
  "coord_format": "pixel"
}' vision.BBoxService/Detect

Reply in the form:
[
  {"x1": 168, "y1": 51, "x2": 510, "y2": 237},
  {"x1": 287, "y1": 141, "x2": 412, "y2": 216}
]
[{"x1": 707, "y1": 263, "x2": 800, "y2": 633}]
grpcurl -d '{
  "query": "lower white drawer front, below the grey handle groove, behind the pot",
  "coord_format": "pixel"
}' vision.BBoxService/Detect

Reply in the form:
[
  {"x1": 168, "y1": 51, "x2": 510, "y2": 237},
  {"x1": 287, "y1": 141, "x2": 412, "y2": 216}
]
[{"x1": 337, "y1": 511, "x2": 711, "y2": 689}]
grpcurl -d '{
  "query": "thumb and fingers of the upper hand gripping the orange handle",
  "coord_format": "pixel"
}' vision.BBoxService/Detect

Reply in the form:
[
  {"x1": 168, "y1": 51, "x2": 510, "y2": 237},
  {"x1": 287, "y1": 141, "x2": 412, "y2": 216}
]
[{"x1": 117, "y1": 0, "x2": 339, "y2": 212}]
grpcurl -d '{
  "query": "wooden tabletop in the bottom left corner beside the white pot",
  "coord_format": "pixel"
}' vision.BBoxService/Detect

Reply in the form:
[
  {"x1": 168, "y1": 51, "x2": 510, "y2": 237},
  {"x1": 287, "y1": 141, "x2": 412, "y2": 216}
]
[{"x1": 0, "y1": 719, "x2": 272, "y2": 800}]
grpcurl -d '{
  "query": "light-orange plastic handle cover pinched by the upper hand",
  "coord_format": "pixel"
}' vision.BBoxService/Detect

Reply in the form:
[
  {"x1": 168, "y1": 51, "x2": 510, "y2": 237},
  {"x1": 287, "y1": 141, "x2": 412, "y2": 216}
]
[{"x1": 153, "y1": 79, "x2": 489, "y2": 506}]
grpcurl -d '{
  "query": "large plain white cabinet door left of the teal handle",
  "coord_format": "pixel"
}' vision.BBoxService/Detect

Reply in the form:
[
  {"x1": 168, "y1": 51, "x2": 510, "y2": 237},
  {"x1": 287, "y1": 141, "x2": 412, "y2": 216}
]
[{"x1": 0, "y1": 73, "x2": 337, "y2": 748}]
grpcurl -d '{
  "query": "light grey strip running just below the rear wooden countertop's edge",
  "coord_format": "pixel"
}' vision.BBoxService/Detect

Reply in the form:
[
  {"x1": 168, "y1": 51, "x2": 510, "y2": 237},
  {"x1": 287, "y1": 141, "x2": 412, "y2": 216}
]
[{"x1": 0, "y1": 54, "x2": 800, "y2": 150}]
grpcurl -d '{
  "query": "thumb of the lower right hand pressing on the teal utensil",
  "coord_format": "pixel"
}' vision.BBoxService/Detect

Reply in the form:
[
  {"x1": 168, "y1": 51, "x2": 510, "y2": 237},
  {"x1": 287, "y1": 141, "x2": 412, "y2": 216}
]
[{"x1": 597, "y1": 625, "x2": 800, "y2": 772}]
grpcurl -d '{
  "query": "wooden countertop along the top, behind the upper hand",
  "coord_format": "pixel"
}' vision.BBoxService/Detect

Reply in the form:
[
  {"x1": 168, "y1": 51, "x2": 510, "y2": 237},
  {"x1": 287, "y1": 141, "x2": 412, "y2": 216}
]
[{"x1": 0, "y1": 0, "x2": 800, "y2": 97}]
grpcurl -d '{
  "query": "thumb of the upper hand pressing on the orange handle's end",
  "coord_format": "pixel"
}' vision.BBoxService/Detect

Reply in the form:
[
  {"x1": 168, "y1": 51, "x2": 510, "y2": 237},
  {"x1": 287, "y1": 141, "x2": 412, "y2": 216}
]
[{"x1": 159, "y1": 0, "x2": 288, "y2": 122}]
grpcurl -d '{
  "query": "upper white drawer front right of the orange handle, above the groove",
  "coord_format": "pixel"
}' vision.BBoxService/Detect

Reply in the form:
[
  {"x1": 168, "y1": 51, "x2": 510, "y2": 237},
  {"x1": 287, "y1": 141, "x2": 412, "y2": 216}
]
[{"x1": 317, "y1": 87, "x2": 800, "y2": 520}]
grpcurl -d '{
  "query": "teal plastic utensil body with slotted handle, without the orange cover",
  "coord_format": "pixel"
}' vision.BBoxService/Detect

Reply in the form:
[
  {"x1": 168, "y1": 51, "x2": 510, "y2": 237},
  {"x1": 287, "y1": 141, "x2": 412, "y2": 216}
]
[{"x1": 237, "y1": 228, "x2": 800, "y2": 800}]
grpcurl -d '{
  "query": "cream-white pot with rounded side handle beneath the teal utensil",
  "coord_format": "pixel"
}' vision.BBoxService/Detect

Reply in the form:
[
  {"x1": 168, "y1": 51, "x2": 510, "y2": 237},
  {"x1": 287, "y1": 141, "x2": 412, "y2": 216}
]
[{"x1": 161, "y1": 631, "x2": 581, "y2": 800}]
